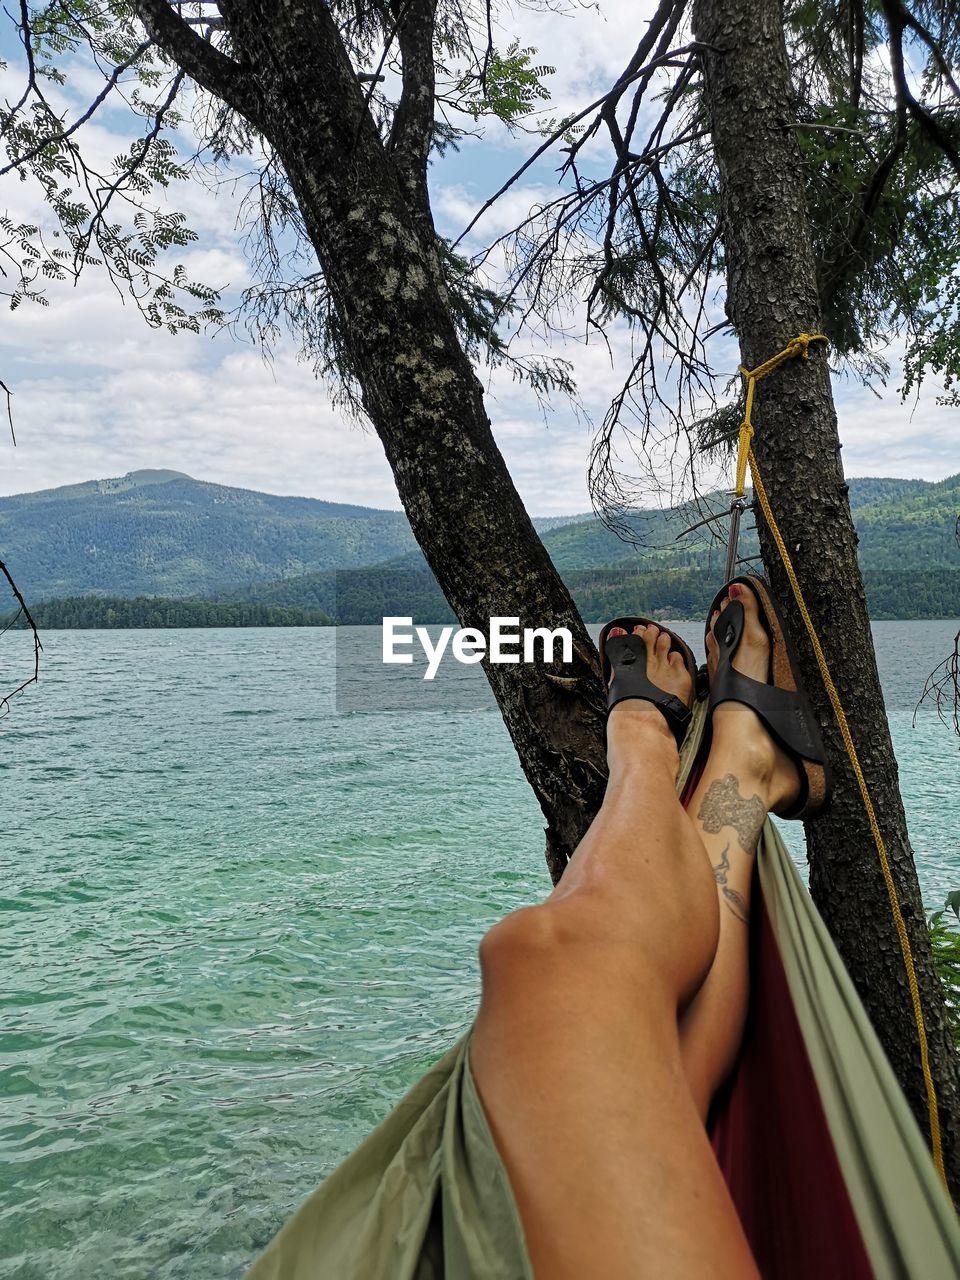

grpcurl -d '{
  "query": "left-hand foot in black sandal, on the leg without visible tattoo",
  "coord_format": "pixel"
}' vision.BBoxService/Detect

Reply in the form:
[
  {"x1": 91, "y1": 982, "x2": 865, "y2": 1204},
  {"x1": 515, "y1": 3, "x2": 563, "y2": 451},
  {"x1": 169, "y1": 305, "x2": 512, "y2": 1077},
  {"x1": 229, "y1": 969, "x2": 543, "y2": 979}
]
[{"x1": 607, "y1": 623, "x2": 694, "y2": 774}]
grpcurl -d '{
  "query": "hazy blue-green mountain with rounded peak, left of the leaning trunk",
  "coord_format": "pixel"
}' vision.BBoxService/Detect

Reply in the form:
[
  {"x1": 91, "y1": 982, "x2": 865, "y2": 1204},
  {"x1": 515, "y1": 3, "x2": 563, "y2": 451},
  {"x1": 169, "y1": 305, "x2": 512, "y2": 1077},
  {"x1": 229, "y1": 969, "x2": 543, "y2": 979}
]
[{"x1": 0, "y1": 471, "x2": 415, "y2": 600}]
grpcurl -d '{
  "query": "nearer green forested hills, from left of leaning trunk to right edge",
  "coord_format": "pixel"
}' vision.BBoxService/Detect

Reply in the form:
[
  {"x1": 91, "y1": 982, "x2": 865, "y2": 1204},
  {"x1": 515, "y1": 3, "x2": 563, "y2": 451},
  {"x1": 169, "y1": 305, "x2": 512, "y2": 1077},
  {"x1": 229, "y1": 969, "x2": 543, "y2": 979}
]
[{"x1": 209, "y1": 476, "x2": 960, "y2": 623}]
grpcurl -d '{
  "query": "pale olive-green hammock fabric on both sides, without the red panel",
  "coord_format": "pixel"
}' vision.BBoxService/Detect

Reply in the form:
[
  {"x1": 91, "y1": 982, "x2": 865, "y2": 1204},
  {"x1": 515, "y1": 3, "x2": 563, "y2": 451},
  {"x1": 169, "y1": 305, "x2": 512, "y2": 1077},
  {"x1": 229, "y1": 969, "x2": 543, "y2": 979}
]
[{"x1": 246, "y1": 704, "x2": 960, "y2": 1280}]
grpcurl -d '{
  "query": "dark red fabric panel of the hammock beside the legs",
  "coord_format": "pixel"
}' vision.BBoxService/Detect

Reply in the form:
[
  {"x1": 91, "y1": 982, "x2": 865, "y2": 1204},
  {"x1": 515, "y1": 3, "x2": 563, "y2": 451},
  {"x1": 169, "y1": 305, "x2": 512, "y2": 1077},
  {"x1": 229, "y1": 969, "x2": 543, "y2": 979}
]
[{"x1": 710, "y1": 884, "x2": 873, "y2": 1280}]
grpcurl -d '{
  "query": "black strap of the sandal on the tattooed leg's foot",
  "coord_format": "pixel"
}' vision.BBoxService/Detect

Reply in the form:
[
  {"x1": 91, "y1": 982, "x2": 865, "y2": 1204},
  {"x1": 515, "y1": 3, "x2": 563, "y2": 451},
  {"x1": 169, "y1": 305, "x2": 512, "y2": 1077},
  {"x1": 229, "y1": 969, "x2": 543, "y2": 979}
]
[{"x1": 710, "y1": 600, "x2": 823, "y2": 763}]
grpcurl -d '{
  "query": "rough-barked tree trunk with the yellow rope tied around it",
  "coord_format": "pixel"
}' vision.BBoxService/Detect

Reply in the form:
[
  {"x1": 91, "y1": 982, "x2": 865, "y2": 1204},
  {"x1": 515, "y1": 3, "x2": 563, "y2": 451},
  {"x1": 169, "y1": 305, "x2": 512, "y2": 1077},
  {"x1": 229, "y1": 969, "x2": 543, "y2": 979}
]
[{"x1": 694, "y1": 0, "x2": 960, "y2": 1193}]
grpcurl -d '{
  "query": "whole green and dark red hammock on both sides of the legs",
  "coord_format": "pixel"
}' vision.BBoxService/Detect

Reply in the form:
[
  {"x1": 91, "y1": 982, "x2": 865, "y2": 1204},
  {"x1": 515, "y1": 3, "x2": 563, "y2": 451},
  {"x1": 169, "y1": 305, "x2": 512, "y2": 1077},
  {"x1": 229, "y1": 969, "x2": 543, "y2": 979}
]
[{"x1": 241, "y1": 703, "x2": 960, "y2": 1280}]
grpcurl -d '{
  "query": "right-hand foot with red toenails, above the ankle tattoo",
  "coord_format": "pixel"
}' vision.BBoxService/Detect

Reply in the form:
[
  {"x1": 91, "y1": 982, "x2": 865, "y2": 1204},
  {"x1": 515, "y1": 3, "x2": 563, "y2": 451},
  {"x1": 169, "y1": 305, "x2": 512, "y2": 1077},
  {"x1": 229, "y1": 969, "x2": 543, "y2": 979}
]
[{"x1": 707, "y1": 582, "x2": 800, "y2": 812}]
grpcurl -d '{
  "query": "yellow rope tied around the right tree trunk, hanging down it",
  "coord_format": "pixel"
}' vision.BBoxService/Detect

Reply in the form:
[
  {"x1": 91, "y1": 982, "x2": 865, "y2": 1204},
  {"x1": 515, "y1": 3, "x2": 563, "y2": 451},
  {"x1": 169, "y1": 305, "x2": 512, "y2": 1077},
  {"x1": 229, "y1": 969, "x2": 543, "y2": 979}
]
[{"x1": 736, "y1": 333, "x2": 950, "y2": 1190}]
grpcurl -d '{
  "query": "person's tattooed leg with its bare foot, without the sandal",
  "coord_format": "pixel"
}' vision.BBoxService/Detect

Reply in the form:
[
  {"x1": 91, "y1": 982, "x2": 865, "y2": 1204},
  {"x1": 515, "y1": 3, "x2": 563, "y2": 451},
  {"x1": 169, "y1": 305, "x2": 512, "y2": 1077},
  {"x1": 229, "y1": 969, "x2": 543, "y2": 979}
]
[{"x1": 681, "y1": 584, "x2": 800, "y2": 1120}]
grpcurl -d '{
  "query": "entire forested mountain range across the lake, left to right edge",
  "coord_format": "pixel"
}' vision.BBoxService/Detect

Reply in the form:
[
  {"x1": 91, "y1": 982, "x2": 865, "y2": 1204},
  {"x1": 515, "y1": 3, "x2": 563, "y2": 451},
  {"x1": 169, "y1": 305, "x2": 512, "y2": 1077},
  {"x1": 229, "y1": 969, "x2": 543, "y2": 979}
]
[{"x1": 0, "y1": 471, "x2": 960, "y2": 621}]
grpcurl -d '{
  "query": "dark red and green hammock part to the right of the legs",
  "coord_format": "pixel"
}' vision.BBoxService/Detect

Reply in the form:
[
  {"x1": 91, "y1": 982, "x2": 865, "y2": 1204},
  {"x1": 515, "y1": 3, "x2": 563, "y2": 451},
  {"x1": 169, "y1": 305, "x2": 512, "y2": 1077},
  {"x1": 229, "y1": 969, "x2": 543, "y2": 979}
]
[{"x1": 681, "y1": 708, "x2": 960, "y2": 1280}]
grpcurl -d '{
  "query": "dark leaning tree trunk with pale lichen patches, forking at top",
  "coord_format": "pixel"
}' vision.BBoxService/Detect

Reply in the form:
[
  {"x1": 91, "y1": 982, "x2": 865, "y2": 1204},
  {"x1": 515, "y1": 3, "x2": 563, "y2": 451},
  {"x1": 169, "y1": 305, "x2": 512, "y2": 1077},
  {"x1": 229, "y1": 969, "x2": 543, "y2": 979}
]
[{"x1": 137, "y1": 0, "x2": 607, "y2": 879}]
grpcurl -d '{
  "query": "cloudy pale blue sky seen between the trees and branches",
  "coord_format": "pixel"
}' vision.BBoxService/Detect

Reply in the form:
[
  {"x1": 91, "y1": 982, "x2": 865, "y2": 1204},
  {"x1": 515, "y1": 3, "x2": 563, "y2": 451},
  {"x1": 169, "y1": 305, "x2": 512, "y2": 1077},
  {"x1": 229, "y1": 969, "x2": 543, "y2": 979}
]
[{"x1": 0, "y1": 0, "x2": 960, "y2": 515}]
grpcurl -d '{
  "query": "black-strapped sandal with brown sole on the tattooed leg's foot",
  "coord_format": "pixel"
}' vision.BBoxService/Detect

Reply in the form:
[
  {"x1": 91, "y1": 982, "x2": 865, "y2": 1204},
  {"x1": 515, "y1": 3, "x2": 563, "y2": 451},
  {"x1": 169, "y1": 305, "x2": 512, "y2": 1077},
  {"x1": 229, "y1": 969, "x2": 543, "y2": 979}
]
[{"x1": 707, "y1": 573, "x2": 832, "y2": 818}]
